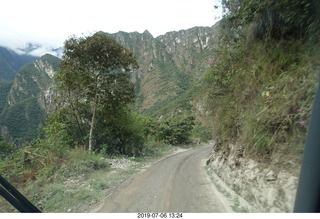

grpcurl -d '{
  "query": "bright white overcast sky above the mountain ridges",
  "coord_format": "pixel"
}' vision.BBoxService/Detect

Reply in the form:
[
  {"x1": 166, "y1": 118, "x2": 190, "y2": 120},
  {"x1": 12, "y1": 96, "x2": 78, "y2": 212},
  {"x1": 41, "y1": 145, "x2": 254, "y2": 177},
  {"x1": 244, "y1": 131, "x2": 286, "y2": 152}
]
[{"x1": 0, "y1": 0, "x2": 221, "y2": 56}]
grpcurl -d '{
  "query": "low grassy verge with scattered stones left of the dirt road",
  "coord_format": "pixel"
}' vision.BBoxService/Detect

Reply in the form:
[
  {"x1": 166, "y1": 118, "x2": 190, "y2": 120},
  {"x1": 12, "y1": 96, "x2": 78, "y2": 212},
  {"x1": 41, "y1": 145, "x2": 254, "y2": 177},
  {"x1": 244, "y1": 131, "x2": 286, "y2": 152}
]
[{"x1": 0, "y1": 140, "x2": 115, "y2": 212}]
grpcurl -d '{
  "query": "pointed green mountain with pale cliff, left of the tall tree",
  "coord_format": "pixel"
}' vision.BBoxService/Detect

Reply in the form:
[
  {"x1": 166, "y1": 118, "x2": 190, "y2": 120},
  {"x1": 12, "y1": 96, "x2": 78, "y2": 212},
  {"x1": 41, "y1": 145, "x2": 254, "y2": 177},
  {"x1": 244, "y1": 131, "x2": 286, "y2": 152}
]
[{"x1": 0, "y1": 55, "x2": 60, "y2": 140}]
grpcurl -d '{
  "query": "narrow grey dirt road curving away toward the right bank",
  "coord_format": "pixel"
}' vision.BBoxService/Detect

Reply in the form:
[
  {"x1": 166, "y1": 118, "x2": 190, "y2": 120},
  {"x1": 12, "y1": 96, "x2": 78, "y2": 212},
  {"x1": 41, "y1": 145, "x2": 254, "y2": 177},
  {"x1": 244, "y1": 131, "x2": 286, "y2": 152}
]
[{"x1": 98, "y1": 145, "x2": 229, "y2": 213}]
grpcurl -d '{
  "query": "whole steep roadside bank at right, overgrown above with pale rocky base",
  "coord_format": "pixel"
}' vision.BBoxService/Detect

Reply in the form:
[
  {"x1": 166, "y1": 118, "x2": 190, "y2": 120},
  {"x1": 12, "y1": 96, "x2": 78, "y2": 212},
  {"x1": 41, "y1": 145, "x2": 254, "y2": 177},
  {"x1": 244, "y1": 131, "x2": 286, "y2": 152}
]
[{"x1": 202, "y1": 0, "x2": 320, "y2": 212}]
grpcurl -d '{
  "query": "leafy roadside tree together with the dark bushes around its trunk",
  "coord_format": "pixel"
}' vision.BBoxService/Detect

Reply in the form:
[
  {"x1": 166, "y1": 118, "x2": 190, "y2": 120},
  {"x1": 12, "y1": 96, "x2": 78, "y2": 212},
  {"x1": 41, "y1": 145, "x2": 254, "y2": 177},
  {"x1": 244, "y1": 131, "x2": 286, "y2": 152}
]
[{"x1": 54, "y1": 33, "x2": 141, "y2": 154}]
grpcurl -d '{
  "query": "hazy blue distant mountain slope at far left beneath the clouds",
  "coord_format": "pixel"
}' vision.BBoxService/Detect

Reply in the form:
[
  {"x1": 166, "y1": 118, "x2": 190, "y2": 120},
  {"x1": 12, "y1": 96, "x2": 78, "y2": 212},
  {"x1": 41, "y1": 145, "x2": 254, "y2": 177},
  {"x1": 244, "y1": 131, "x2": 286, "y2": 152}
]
[{"x1": 0, "y1": 46, "x2": 37, "y2": 81}]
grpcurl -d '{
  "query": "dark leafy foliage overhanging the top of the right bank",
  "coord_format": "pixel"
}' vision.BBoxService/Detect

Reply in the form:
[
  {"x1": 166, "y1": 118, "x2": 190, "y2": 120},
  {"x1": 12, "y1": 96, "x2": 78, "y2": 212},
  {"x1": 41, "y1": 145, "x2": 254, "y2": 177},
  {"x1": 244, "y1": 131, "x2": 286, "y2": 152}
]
[{"x1": 222, "y1": 0, "x2": 320, "y2": 40}]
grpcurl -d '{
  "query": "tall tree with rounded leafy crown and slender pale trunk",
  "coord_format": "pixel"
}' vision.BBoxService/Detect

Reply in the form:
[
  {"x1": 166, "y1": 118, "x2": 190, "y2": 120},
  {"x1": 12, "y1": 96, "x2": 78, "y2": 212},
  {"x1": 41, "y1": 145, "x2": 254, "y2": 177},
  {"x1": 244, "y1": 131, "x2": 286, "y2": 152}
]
[{"x1": 57, "y1": 32, "x2": 138, "y2": 151}]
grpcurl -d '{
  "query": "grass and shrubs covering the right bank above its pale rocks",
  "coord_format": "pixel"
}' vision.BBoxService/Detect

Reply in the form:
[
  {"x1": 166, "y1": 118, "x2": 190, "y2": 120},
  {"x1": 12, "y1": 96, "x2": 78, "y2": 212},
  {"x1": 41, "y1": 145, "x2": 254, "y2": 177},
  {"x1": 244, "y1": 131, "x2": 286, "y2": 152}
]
[{"x1": 204, "y1": 0, "x2": 320, "y2": 157}]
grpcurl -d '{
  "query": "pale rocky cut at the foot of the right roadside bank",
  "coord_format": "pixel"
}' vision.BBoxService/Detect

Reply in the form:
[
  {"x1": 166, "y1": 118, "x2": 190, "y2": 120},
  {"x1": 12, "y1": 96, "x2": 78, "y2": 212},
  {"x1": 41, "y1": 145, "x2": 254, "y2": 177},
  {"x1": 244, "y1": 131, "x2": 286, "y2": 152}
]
[{"x1": 207, "y1": 145, "x2": 300, "y2": 212}]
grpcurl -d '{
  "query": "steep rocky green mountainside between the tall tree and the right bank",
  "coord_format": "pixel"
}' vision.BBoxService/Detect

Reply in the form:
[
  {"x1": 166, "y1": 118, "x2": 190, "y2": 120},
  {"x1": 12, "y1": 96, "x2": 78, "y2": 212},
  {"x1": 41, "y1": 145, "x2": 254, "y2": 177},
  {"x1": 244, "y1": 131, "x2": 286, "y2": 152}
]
[{"x1": 112, "y1": 25, "x2": 217, "y2": 116}]
